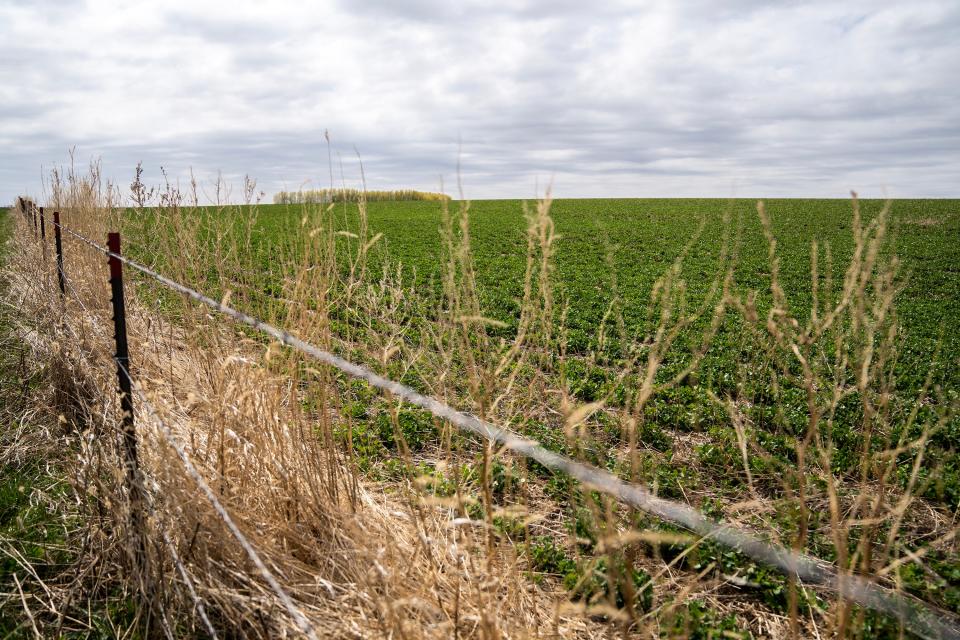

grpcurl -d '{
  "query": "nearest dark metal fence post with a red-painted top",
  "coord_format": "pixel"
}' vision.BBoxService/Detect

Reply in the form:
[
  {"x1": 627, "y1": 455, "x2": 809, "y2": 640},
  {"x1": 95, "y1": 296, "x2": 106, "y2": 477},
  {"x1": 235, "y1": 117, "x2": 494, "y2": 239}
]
[{"x1": 107, "y1": 232, "x2": 147, "y2": 581}]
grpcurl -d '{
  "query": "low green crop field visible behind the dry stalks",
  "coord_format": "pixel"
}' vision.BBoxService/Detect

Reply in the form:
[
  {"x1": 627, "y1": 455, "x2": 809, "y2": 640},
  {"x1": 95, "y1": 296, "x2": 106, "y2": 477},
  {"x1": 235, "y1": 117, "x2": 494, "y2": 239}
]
[{"x1": 127, "y1": 199, "x2": 960, "y2": 624}]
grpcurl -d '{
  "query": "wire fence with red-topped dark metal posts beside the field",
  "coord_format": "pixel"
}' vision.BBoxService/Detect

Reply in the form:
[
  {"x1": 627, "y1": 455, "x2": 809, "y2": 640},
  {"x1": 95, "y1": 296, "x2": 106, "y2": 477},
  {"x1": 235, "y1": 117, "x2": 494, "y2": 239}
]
[{"x1": 7, "y1": 198, "x2": 960, "y2": 639}]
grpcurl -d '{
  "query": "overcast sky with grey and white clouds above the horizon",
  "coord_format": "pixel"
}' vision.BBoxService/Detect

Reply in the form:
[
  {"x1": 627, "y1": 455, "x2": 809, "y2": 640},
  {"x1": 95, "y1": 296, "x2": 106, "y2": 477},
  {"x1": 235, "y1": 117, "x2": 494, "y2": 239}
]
[{"x1": 0, "y1": 0, "x2": 960, "y2": 201}]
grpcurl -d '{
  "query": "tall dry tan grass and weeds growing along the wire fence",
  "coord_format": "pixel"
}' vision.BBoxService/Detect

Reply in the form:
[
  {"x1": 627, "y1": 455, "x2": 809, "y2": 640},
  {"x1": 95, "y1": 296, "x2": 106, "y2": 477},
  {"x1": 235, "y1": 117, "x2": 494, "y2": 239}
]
[{"x1": 4, "y1": 159, "x2": 958, "y2": 638}]
